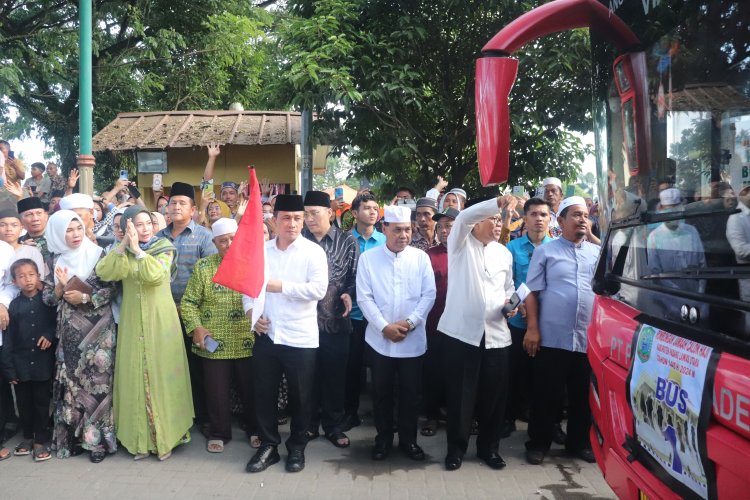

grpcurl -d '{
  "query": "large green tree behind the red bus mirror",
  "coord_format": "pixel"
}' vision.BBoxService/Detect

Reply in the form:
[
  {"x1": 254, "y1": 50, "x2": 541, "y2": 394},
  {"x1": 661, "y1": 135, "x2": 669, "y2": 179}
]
[{"x1": 279, "y1": 0, "x2": 591, "y2": 199}]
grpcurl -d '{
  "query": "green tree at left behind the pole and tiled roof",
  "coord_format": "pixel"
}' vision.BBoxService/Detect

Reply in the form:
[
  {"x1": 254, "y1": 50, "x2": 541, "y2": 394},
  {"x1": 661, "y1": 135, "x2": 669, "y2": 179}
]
[{"x1": 0, "y1": 0, "x2": 280, "y2": 189}]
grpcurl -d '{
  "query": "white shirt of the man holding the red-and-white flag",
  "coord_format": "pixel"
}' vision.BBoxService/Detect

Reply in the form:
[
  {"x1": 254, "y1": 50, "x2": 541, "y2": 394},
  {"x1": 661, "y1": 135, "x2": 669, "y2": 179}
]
[{"x1": 242, "y1": 235, "x2": 328, "y2": 348}]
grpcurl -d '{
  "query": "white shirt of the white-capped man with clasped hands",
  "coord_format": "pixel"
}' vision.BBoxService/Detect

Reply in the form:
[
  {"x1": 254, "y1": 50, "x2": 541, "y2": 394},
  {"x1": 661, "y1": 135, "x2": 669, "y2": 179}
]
[{"x1": 357, "y1": 245, "x2": 435, "y2": 358}]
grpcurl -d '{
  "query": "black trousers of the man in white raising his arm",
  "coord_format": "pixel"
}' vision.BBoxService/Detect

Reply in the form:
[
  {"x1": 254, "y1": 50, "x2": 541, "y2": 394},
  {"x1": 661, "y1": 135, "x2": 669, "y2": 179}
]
[{"x1": 441, "y1": 334, "x2": 510, "y2": 457}]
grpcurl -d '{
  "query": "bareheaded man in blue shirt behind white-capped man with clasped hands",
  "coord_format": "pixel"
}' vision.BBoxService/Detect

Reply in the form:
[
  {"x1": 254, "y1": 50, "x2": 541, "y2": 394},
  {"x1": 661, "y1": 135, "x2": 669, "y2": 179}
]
[{"x1": 342, "y1": 191, "x2": 385, "y2": 432}]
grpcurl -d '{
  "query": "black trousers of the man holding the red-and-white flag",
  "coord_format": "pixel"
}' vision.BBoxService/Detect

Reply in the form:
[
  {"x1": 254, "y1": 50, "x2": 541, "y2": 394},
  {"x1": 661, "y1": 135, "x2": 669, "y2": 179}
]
[{"x1": 253, "y1": 335, "x2": 317, "y2": 450}]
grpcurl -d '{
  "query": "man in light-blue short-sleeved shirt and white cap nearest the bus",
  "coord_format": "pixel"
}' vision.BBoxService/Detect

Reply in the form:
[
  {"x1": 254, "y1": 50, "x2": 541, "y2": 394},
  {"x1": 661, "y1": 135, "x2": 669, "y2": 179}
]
[{"x1": 523, "y1": 196, "x2": 599, "y2": 465}]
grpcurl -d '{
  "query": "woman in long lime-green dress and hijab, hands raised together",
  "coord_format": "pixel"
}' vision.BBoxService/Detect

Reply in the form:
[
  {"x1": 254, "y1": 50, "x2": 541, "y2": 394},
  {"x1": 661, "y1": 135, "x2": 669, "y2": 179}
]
[{"x1": 96, "y1": 206, "x2": 193, "y2": 460}]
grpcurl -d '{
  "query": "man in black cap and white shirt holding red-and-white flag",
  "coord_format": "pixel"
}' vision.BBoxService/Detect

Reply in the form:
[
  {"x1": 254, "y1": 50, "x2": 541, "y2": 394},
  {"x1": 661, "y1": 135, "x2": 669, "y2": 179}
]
[{"x1": 234, "y1": 193, "x2": 328, "y2": 472}]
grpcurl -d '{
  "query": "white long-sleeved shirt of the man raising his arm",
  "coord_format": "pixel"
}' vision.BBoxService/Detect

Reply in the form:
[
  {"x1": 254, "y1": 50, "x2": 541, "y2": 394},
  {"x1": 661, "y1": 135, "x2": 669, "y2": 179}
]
[{"x1": 438, "y1": 199, "x2": 515, "y2": 349}]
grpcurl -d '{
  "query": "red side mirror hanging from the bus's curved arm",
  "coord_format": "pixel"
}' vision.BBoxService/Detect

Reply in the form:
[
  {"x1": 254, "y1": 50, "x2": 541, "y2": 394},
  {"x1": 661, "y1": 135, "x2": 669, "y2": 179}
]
[{"x1": 474, "y1": 56, "x2": 518, "y2": 186}]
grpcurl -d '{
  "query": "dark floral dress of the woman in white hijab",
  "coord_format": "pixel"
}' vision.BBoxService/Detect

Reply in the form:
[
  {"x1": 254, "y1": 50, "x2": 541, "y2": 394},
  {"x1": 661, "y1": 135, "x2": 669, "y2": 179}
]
[{"x1": 42, "y1": 256, "x2": 117, "y2": 458}]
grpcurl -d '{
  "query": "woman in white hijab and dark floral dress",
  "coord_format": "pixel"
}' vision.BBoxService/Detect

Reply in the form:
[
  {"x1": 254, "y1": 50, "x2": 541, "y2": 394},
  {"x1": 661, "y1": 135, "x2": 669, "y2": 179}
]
[{"x1": 43, "y1": 210, "x2": 117, "y2": 463}]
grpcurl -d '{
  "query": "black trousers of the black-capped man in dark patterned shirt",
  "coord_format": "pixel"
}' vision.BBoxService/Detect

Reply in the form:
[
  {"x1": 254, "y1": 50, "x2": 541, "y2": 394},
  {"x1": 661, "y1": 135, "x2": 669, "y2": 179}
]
[{"x1": 310, "y1": 330, "x2": 351, "y2": 434}]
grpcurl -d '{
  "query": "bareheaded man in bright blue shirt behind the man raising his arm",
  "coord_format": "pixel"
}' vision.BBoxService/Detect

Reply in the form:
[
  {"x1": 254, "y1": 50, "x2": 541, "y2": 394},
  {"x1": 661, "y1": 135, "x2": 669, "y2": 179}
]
[{"x1": 502, "y1": 198, "x2": 552, "y2": 437}]
